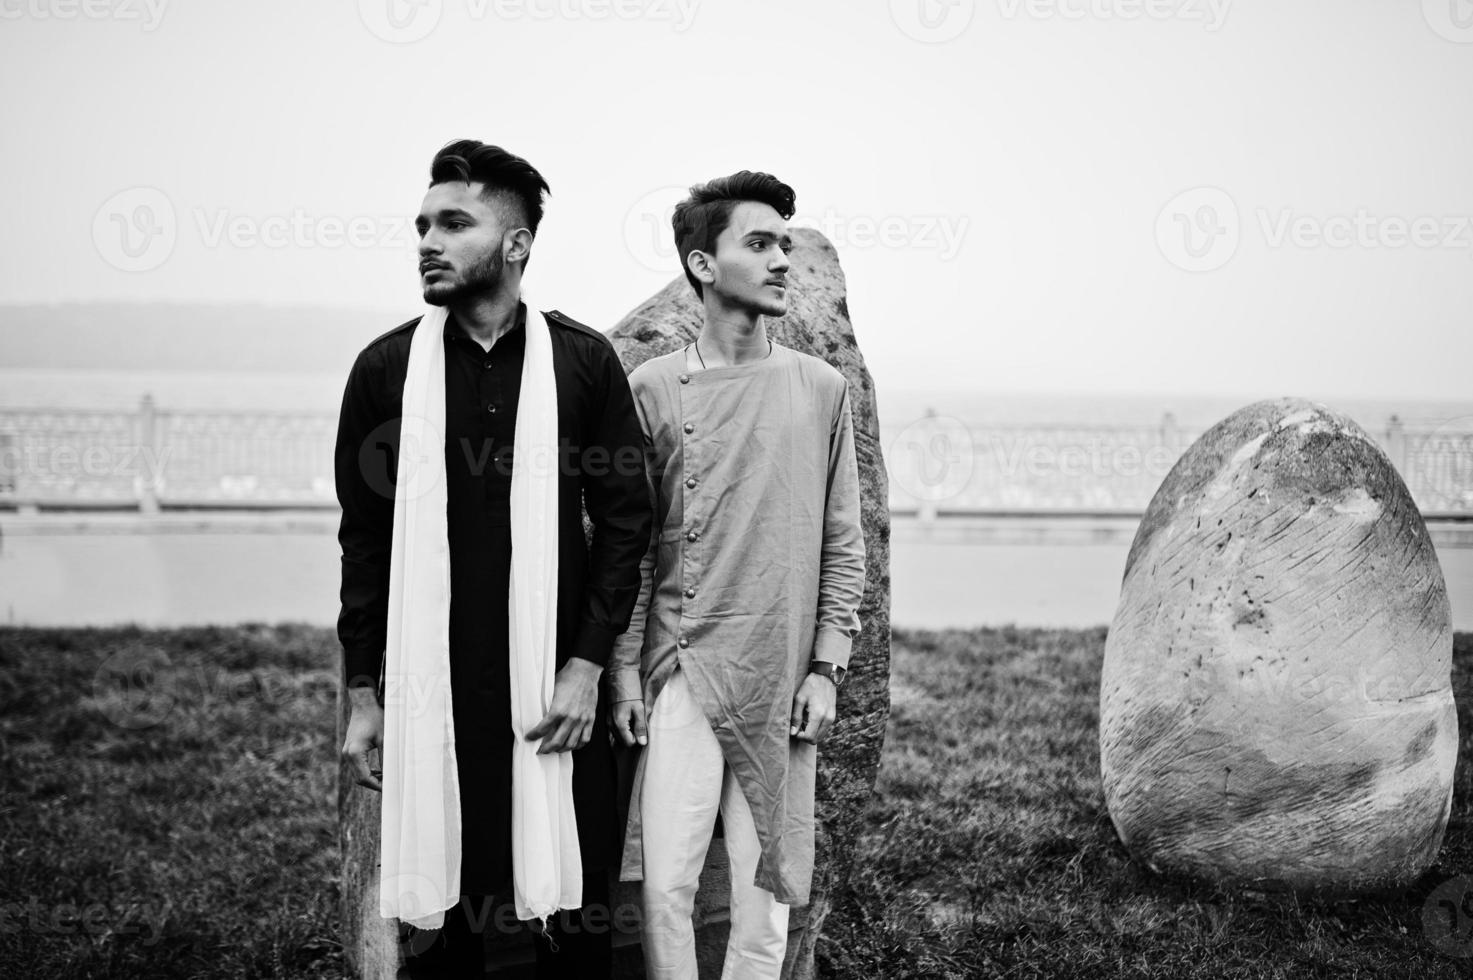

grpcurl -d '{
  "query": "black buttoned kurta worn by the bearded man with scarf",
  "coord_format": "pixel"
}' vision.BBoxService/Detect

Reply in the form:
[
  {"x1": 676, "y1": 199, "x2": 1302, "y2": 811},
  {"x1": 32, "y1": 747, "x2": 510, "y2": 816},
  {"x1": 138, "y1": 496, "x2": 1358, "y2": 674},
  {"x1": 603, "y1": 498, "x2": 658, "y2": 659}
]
[{"x1": 334, "y1": 307, "x2": 651, "y2": 893}]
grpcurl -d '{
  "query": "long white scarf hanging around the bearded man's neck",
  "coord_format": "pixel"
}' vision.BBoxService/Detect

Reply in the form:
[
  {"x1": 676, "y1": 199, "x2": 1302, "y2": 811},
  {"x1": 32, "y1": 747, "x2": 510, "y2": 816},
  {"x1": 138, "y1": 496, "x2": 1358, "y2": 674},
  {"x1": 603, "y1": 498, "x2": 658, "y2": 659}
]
[{"x1": 379, "y1": 300, "x2": 583, "y2": 928}]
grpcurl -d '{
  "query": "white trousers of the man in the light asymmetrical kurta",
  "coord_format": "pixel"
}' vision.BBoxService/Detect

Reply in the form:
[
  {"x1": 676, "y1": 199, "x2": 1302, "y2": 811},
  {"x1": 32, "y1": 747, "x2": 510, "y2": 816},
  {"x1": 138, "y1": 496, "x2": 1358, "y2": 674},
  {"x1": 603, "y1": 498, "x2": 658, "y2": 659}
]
[{"x1": 639, "y1": 669, "x2": 788, "y2": 980}]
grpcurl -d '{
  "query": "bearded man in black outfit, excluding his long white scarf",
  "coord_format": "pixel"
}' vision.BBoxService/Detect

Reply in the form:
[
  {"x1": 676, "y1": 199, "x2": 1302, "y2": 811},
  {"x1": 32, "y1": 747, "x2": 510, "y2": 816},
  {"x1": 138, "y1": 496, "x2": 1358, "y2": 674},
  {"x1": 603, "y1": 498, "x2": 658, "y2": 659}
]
[{"x1": 334, "y1": 140, "x2": 651, "y2": 977}]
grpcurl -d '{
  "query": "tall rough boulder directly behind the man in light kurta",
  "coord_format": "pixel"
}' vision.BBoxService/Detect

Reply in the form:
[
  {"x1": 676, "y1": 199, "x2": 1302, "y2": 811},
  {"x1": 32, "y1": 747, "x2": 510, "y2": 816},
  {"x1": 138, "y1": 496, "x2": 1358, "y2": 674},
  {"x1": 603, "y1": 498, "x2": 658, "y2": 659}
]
[{"x1": 610, "y1": 228, "x2": 890, "y2": 980}]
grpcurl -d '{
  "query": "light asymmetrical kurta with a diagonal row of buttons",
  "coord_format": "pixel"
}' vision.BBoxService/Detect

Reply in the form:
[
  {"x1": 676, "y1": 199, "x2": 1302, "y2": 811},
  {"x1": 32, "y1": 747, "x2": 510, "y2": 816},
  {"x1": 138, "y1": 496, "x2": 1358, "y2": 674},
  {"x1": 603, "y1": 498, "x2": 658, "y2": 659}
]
[{"x1": 608, "y1": 343, "x2": 865, "y2": 905}]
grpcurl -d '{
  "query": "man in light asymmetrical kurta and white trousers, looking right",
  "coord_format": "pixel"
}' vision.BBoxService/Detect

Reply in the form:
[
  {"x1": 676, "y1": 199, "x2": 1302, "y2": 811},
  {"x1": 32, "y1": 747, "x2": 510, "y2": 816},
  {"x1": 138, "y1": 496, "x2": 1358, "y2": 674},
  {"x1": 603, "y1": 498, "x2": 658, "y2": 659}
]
[{"x1": 608, "y1": 171, "x2": 865, "y2": 980}]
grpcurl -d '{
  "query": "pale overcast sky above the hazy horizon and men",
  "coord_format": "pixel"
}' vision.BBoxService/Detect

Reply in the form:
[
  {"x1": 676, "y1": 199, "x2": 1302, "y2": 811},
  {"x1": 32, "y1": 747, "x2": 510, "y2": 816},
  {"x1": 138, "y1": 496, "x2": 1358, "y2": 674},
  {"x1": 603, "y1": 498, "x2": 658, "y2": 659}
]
[{"x1": 0, "y1": 0, "x2": 1473, "y2": 398}]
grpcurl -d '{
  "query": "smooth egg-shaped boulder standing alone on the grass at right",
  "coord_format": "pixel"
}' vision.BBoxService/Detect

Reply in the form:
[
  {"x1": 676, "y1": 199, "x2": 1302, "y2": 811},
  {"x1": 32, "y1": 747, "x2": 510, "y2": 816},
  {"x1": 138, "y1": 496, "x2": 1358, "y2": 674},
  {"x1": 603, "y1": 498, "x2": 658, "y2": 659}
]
[{"x1": 1100, "y1": 399, "x2": 1458, "y2": 893}]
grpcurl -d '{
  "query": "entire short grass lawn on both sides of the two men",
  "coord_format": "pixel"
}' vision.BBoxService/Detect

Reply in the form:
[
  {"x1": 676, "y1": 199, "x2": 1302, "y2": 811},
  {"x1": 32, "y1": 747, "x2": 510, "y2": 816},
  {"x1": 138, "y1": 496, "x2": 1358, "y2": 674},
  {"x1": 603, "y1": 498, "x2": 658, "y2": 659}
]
[{"x1": 0, "y1": 626, "x2": 1473, "y2": 980}]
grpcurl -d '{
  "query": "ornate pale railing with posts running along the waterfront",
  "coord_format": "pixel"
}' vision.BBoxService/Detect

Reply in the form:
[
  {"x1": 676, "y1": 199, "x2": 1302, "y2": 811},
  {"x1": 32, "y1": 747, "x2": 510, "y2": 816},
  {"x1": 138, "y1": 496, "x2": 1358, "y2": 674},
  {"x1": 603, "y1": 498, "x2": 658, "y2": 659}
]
[{"x1": 0, "y1": 398, "x2": 1473, "y2": 520}]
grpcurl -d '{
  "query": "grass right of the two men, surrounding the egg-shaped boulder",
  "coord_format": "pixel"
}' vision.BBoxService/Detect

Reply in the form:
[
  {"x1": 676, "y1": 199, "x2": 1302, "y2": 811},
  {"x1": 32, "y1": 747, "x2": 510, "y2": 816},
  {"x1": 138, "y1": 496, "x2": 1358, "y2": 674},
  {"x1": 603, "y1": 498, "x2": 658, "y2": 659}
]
[{"x1": 819, "y1": 628, "x2": 1473, "y2": 980}]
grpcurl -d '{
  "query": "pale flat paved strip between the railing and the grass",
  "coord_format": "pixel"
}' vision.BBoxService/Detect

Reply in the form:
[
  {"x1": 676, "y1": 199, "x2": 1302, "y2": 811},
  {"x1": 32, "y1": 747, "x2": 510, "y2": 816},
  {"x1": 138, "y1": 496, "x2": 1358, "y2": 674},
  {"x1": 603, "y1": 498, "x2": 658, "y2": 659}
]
[{"x1": 0, "y1": 516, "x2": 1473, "y2": 631}]
